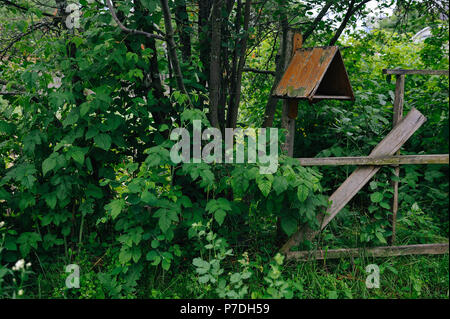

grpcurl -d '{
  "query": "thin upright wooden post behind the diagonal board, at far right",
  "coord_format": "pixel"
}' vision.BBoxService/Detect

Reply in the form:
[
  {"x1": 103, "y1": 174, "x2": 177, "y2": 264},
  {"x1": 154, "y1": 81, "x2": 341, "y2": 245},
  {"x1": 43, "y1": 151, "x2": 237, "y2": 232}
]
[{"x1": 389, "y1": 74, "x2": 405, "y2": 245}]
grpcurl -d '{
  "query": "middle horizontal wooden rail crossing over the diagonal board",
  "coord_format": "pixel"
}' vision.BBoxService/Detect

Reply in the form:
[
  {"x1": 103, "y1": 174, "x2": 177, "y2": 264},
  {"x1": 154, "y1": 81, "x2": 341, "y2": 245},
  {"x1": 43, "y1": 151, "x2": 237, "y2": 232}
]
[{"x1": 296, "y1": 154, "x2": 449, "y2": 166}]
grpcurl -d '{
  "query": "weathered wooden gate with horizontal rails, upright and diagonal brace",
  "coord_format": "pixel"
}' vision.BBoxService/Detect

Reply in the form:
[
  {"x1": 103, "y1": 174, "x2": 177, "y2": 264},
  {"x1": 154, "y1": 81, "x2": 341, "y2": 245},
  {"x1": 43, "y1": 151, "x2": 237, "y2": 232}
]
[{"x1": 281, "y1": 64, "x2": 449, "y2": 260}]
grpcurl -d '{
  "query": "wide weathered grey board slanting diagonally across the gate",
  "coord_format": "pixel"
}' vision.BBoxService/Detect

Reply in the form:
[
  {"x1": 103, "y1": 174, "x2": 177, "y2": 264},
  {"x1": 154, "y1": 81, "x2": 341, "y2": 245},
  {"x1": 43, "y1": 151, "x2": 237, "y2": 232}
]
[{"x1": 281, "y1": 108, "x2": 426, "y2": 253}]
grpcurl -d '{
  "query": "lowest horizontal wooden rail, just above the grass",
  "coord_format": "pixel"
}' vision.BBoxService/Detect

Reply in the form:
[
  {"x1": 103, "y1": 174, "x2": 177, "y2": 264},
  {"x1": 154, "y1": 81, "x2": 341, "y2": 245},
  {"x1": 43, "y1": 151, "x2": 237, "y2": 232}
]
[{"x1": 286, "y1": 243, "x2": 449, "y2": 261}]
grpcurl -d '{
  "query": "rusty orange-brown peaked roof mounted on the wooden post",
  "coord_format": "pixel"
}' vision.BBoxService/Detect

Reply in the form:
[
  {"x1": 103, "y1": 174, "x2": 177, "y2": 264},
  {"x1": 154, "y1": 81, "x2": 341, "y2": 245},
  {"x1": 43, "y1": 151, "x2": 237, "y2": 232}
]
[{"x1": 273, "y1": 46, "x2": 354, "y2": 101}]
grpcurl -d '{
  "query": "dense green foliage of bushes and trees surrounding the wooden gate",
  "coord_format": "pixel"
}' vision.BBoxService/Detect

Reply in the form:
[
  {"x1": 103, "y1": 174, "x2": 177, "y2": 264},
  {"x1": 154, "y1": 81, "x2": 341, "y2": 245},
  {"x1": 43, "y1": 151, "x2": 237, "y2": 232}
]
[{"x1": 0, "y1": 0, "x2": 449, "y2": 298}]
